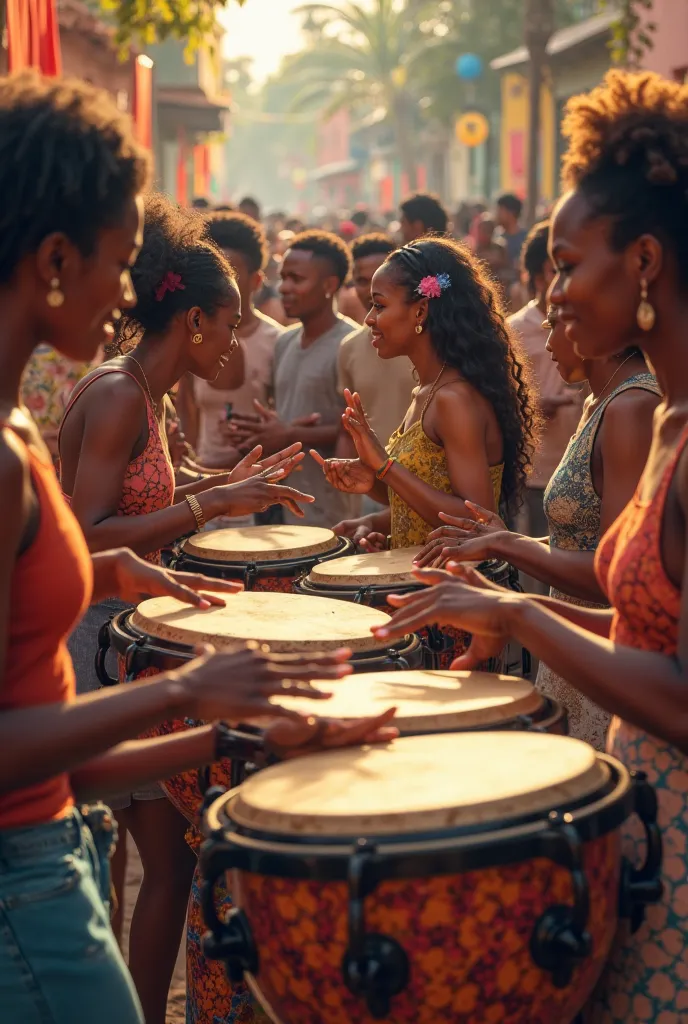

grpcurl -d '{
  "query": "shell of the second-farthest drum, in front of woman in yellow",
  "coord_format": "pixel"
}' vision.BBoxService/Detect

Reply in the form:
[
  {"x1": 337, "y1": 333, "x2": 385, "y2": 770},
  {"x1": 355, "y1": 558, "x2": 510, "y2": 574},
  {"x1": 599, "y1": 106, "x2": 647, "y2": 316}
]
[{"x1": 293, "y1": 559, "x2": 513, "y2": 672}]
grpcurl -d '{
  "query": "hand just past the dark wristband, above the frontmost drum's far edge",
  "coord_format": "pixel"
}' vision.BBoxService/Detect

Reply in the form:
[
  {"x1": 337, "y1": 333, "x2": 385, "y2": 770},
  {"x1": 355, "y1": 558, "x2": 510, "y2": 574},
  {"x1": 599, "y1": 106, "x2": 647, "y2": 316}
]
[{"x1": 265, "y1": 708, "x2": 399, "y2": 761}]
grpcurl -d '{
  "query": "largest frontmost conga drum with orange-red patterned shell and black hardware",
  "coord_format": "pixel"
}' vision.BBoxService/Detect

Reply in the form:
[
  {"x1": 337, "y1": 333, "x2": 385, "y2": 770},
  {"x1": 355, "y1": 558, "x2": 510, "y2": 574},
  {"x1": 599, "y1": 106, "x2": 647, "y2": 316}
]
[{"x1": 201, "y1": 732, "x2": 660, "y2": 1024}]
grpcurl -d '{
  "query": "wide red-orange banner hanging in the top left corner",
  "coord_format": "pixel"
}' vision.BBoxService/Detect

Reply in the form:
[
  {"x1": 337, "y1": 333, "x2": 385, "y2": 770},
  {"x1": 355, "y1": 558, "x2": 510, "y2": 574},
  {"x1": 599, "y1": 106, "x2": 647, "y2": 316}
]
[{"x1": 7, "y1": 0, "x2": 62, "y2": 75}]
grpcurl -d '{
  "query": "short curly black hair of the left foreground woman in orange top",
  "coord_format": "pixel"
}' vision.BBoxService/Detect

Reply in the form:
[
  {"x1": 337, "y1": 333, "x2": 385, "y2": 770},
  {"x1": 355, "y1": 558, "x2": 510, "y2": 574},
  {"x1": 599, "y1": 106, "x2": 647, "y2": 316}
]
[{"x1": 0, "y1": 72, "x2": 149, "y2": 283}]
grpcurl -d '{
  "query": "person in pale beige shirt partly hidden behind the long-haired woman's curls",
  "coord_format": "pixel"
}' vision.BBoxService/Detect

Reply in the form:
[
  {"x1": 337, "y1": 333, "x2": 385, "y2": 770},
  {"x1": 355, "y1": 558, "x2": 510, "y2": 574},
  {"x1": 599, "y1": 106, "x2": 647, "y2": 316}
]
[{"x1": 509, "y1": 221, "x2": 585, "y2": 537}]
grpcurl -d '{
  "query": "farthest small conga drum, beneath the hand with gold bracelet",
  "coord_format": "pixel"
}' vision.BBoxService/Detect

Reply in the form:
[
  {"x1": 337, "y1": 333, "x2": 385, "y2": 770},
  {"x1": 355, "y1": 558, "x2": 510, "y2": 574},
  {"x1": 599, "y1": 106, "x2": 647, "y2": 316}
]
[{"x1": 173, "y1": 525, "x2": 354, "y2": 594}]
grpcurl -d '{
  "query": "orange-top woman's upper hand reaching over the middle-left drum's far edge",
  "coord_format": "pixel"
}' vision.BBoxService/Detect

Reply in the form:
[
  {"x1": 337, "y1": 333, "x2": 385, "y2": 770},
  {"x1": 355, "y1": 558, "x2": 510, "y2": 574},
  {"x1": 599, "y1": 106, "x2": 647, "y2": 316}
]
[{"x1": 111, "y1": 548, "x2": 244, "y2": 608}]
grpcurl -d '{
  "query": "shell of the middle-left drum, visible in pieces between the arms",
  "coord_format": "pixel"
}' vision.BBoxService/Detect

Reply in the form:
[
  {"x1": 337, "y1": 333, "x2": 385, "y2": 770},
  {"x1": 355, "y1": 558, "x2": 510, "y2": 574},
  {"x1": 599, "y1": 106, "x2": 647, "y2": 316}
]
[{"x1": 102, "y1": 611, "x2": 429, "y2": 827}]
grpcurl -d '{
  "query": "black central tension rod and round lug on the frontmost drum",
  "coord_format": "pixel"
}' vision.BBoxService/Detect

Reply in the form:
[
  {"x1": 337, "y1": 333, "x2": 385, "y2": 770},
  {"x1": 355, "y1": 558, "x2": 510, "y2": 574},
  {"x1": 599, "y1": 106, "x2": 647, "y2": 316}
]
[{"x1": 342, "y1": 839, "x2": 410, "y2": 1020}]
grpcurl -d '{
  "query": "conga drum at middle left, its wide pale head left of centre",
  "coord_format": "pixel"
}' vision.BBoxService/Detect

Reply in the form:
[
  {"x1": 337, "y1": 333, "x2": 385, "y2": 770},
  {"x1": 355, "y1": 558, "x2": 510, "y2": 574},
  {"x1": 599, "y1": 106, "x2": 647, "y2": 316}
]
[{"x1": 97, "y1": 591, "x2": 427, "y2": 824}]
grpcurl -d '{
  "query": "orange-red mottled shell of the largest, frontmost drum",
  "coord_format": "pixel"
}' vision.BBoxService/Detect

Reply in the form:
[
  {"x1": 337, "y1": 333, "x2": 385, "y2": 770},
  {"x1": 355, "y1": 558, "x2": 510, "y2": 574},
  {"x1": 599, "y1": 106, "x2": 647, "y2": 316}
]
[{"x1": 202, "y1": 759, "x2": 632, "y2": 1024}]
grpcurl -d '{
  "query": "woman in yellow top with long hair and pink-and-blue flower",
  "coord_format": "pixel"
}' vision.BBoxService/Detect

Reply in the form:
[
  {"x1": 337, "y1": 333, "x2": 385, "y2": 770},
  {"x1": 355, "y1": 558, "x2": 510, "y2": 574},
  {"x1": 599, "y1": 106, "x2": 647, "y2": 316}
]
[{"x1": 311, "y1": 239, "x2": 534, "y2": 550}]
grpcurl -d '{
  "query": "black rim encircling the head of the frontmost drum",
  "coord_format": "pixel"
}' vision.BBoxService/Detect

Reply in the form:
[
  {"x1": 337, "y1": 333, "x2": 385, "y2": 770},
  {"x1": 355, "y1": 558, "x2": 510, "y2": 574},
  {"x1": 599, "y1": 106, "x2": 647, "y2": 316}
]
[{"x1": 203, "y1": 753, "x2": 635, "y2": 882}]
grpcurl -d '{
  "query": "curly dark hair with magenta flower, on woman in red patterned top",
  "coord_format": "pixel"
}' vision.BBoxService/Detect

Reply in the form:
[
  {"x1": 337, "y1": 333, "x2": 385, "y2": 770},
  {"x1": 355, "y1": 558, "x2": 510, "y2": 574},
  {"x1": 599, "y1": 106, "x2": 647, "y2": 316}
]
[{"x1": 117, "y1": 194, "x2": 237, "y2": 349}]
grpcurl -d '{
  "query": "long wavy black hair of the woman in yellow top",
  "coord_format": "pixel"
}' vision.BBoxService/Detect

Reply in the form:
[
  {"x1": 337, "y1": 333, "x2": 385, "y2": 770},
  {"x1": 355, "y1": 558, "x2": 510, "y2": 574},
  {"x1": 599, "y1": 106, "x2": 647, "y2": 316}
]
[{"x1": 385, "y1": 238, "x2": 539, "y2": 512}]
